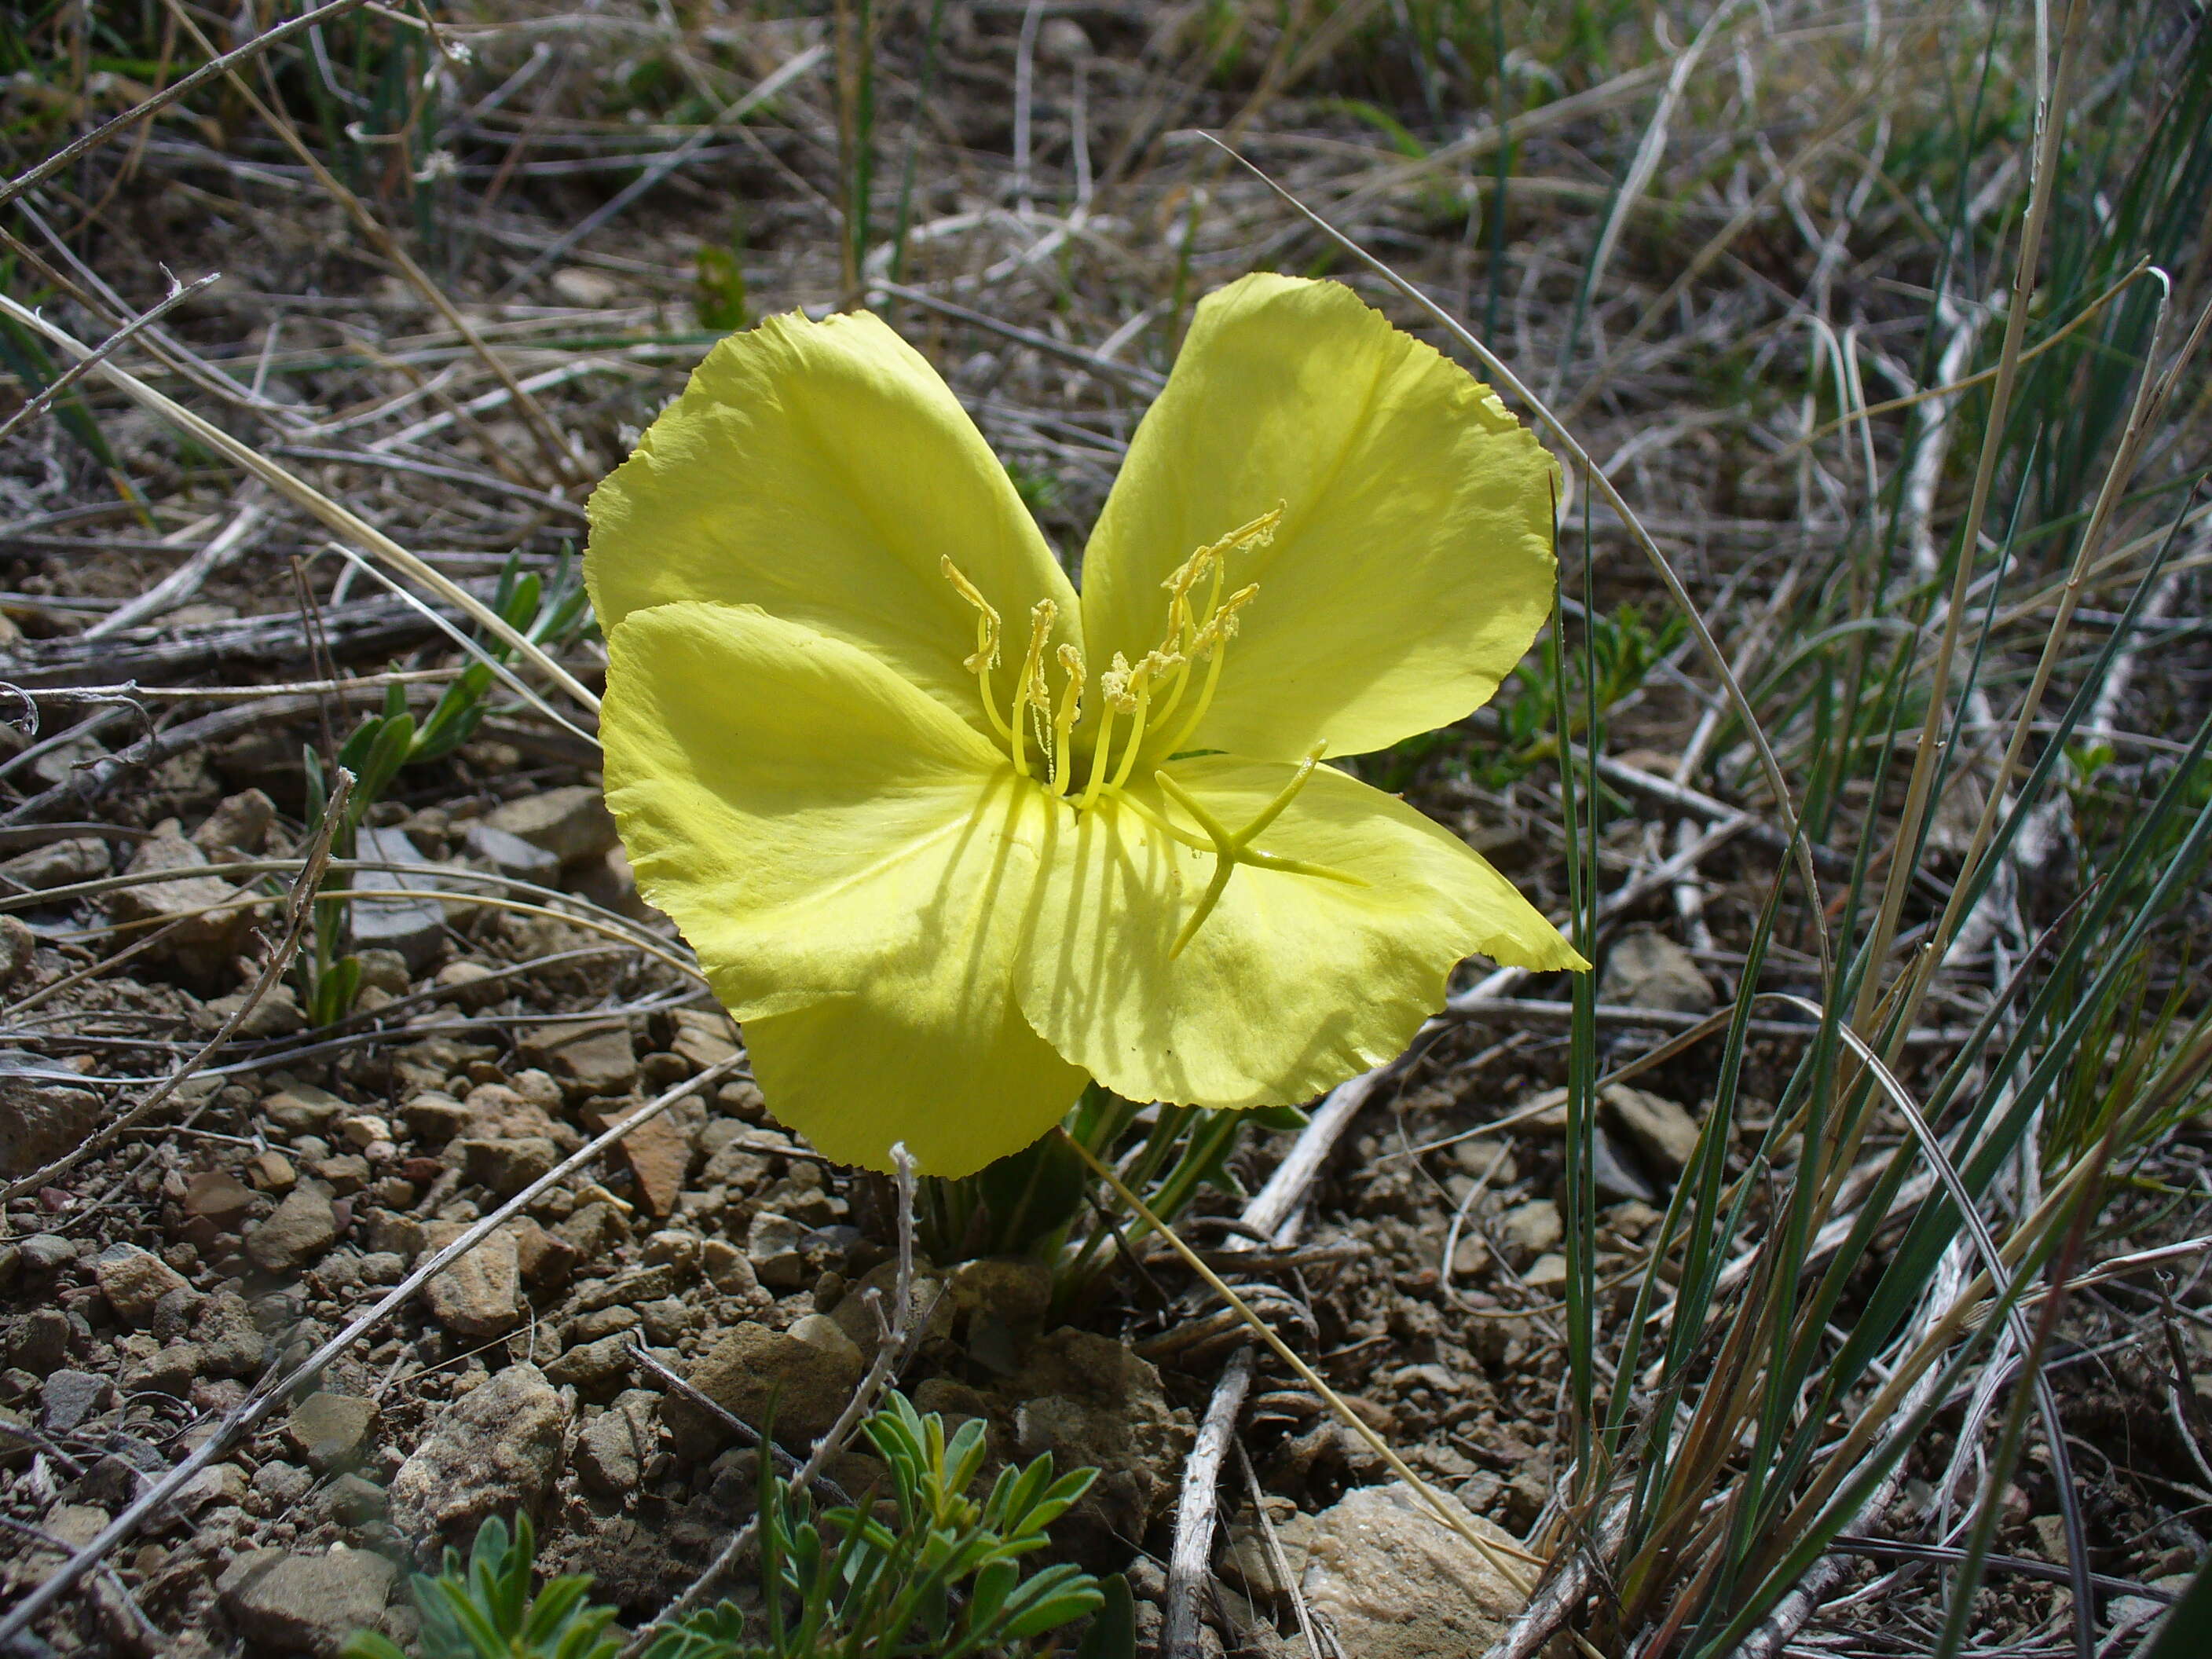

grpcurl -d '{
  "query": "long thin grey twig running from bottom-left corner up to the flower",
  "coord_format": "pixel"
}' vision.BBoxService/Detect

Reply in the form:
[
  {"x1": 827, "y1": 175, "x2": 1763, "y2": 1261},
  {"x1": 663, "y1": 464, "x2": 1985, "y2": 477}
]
[{"x1": 0, "y1": 1055, "x2": 745, "y2": 1650}]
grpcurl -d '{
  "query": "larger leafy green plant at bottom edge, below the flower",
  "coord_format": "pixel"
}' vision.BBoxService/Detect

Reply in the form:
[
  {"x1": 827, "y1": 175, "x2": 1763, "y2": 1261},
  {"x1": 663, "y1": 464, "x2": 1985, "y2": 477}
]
[{"x1": 646, "y1": 1393, "x2": 1115, "y2": 1659}]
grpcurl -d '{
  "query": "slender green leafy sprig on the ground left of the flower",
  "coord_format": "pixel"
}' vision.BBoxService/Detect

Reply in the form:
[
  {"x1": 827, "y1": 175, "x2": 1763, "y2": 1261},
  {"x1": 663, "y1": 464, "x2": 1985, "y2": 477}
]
[{"x1": 298, "y1": 559, "x2": 586, "y2": 1027}]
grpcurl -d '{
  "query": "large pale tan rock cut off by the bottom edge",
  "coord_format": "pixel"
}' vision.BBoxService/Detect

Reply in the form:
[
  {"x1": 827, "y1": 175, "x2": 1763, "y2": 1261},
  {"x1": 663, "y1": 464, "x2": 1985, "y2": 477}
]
[{"x1": 1305, "y1": 1482, "x2": 1524, "y2": 1659}]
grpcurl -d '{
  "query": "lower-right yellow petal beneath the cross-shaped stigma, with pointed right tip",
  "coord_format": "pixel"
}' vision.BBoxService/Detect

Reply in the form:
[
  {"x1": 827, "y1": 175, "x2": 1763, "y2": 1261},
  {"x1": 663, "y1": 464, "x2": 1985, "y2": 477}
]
[{"x1": 1020, "y1": 756, "x2": 1586, "y2": 1106}]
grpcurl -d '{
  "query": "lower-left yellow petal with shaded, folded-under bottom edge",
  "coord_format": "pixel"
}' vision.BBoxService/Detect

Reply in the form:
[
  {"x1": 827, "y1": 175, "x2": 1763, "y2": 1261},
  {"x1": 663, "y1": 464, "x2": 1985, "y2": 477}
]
[{"x1": 599, "y1": 602, "x2": 1084, "y2": 1174}]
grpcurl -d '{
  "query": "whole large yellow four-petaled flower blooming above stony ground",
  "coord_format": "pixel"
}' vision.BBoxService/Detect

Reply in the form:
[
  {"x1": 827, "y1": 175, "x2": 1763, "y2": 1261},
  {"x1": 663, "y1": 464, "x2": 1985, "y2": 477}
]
[{"x1": 584, "y1": 274, "x2": 1586, "y2": 1174}]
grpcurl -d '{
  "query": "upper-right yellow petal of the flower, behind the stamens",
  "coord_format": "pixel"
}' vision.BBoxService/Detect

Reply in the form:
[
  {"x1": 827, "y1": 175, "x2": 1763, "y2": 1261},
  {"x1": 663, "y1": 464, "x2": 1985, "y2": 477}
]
[{"x1": 1084, "y1": 274, "x2": 1553, "y2": 761}]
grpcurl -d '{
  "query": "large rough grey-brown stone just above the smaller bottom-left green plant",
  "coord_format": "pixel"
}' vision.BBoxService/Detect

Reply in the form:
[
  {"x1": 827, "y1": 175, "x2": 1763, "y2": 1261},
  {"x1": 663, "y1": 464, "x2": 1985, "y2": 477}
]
[{"x1": 391, "y1": 1364, "x2": 569, "y2": 1553}]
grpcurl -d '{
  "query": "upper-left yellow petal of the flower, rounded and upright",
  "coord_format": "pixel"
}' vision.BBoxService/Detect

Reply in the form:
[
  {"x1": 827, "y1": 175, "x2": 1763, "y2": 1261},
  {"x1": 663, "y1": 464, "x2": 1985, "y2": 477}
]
[{"x1": 584, "y1": 312, "x2": 1077, "y2": 747}]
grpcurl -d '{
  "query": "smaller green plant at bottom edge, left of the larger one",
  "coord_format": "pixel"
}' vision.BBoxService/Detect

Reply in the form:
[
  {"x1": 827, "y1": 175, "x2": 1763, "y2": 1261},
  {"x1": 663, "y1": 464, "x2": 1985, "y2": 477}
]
[{"x1": 342, "y1": 1515, "x2": 621, "y2": 1659}]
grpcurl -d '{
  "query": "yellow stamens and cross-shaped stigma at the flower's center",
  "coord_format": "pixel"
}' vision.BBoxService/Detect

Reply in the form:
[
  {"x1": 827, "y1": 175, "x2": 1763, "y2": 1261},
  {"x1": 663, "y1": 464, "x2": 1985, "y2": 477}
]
[{"x1": 940, "y1": 507, "x2": 1367, "y2": 956}]
